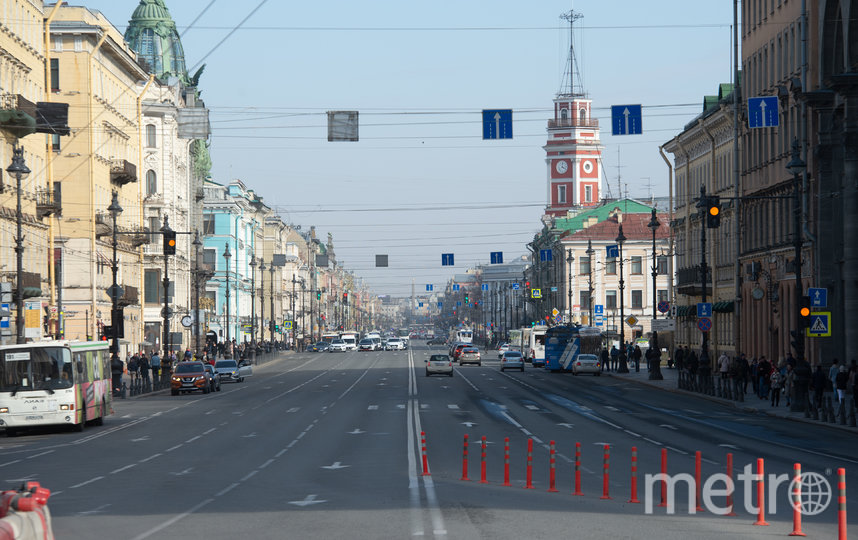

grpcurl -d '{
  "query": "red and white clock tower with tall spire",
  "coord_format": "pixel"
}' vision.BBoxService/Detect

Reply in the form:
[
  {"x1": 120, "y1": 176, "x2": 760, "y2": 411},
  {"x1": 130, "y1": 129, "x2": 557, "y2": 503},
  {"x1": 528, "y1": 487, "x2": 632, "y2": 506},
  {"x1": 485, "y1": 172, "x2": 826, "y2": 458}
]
[{"x1": 543, "y1": 12, "x2": 604, "y2": 216}]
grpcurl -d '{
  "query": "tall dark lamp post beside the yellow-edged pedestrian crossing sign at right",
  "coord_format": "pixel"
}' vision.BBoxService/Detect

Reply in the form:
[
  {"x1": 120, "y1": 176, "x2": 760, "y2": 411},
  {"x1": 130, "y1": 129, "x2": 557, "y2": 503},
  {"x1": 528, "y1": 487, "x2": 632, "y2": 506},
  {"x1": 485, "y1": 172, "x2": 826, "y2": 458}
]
[{"x1": 786, "y1": 139, "x2": 811, "y2": 411}]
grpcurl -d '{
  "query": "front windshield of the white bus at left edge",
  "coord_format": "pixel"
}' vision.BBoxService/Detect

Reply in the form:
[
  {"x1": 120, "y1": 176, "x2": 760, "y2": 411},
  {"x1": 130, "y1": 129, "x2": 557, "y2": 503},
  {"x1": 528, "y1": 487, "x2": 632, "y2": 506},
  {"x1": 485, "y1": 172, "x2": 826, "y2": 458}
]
[{"x1": 0, "y1": 347, "x2": 74, "y2": 392}]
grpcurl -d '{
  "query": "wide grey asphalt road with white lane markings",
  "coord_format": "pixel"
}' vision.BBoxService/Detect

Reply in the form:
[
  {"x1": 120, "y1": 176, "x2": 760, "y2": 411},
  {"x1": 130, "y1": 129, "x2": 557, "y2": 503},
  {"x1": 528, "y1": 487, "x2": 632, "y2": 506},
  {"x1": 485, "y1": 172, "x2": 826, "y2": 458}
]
[{"x1": 0, "y1": 342, "x2": 858, "y2": 540}]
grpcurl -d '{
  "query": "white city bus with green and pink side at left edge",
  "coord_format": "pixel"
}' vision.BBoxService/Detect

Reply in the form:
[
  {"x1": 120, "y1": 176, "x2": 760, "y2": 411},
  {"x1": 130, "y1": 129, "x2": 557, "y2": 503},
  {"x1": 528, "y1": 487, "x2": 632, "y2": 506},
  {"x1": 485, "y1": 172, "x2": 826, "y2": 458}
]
[{"x1": 0, "y1": 341, "x2": 112, "y2": 437}]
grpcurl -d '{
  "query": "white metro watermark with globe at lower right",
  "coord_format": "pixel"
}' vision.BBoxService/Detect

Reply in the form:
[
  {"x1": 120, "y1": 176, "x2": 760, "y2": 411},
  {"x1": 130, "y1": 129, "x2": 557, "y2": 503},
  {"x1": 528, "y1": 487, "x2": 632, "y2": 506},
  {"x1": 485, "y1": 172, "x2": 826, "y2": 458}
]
[{"x1": 644, "y1": 464, "x2": 833, "y2": 516}]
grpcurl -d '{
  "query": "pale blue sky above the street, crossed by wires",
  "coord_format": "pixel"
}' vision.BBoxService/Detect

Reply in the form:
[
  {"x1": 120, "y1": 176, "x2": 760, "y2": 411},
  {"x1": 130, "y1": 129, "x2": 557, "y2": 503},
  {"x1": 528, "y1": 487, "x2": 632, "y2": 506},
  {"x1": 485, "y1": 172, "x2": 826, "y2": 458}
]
[{"x1": 80, "y1": 0, "x2": 733, "y2": 296}]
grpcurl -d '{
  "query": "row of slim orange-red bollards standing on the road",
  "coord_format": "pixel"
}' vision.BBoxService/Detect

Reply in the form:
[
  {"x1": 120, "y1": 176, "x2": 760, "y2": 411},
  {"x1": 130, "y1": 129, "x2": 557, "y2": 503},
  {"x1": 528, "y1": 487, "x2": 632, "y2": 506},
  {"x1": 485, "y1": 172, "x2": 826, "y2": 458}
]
[{"x1": 452, "y1": 432, "x2": 847, "y2": 540}]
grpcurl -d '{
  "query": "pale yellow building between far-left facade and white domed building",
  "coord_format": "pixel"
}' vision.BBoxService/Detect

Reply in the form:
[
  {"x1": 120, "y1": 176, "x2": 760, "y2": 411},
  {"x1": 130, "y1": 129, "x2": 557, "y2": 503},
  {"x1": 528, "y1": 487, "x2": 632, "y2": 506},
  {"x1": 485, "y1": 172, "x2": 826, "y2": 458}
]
[{"x1": 48, "y1": 4, "x2": 150, "y2": 356}]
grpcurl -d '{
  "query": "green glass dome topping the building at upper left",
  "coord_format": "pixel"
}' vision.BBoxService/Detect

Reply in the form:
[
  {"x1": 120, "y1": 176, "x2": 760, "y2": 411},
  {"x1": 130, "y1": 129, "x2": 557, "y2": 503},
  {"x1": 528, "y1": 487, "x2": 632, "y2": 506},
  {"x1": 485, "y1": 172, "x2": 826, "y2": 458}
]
[{"x1": 125, "y1": 0, "x2": 188, "y2": 83}]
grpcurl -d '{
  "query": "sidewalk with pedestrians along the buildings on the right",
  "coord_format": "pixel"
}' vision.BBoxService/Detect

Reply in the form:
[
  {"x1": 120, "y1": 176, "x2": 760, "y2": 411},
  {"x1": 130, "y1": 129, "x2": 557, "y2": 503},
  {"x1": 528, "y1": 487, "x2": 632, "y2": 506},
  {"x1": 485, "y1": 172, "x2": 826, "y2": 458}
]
[{"x1": 604, "y1": 362, "x2": 858, "y2": 433}]
